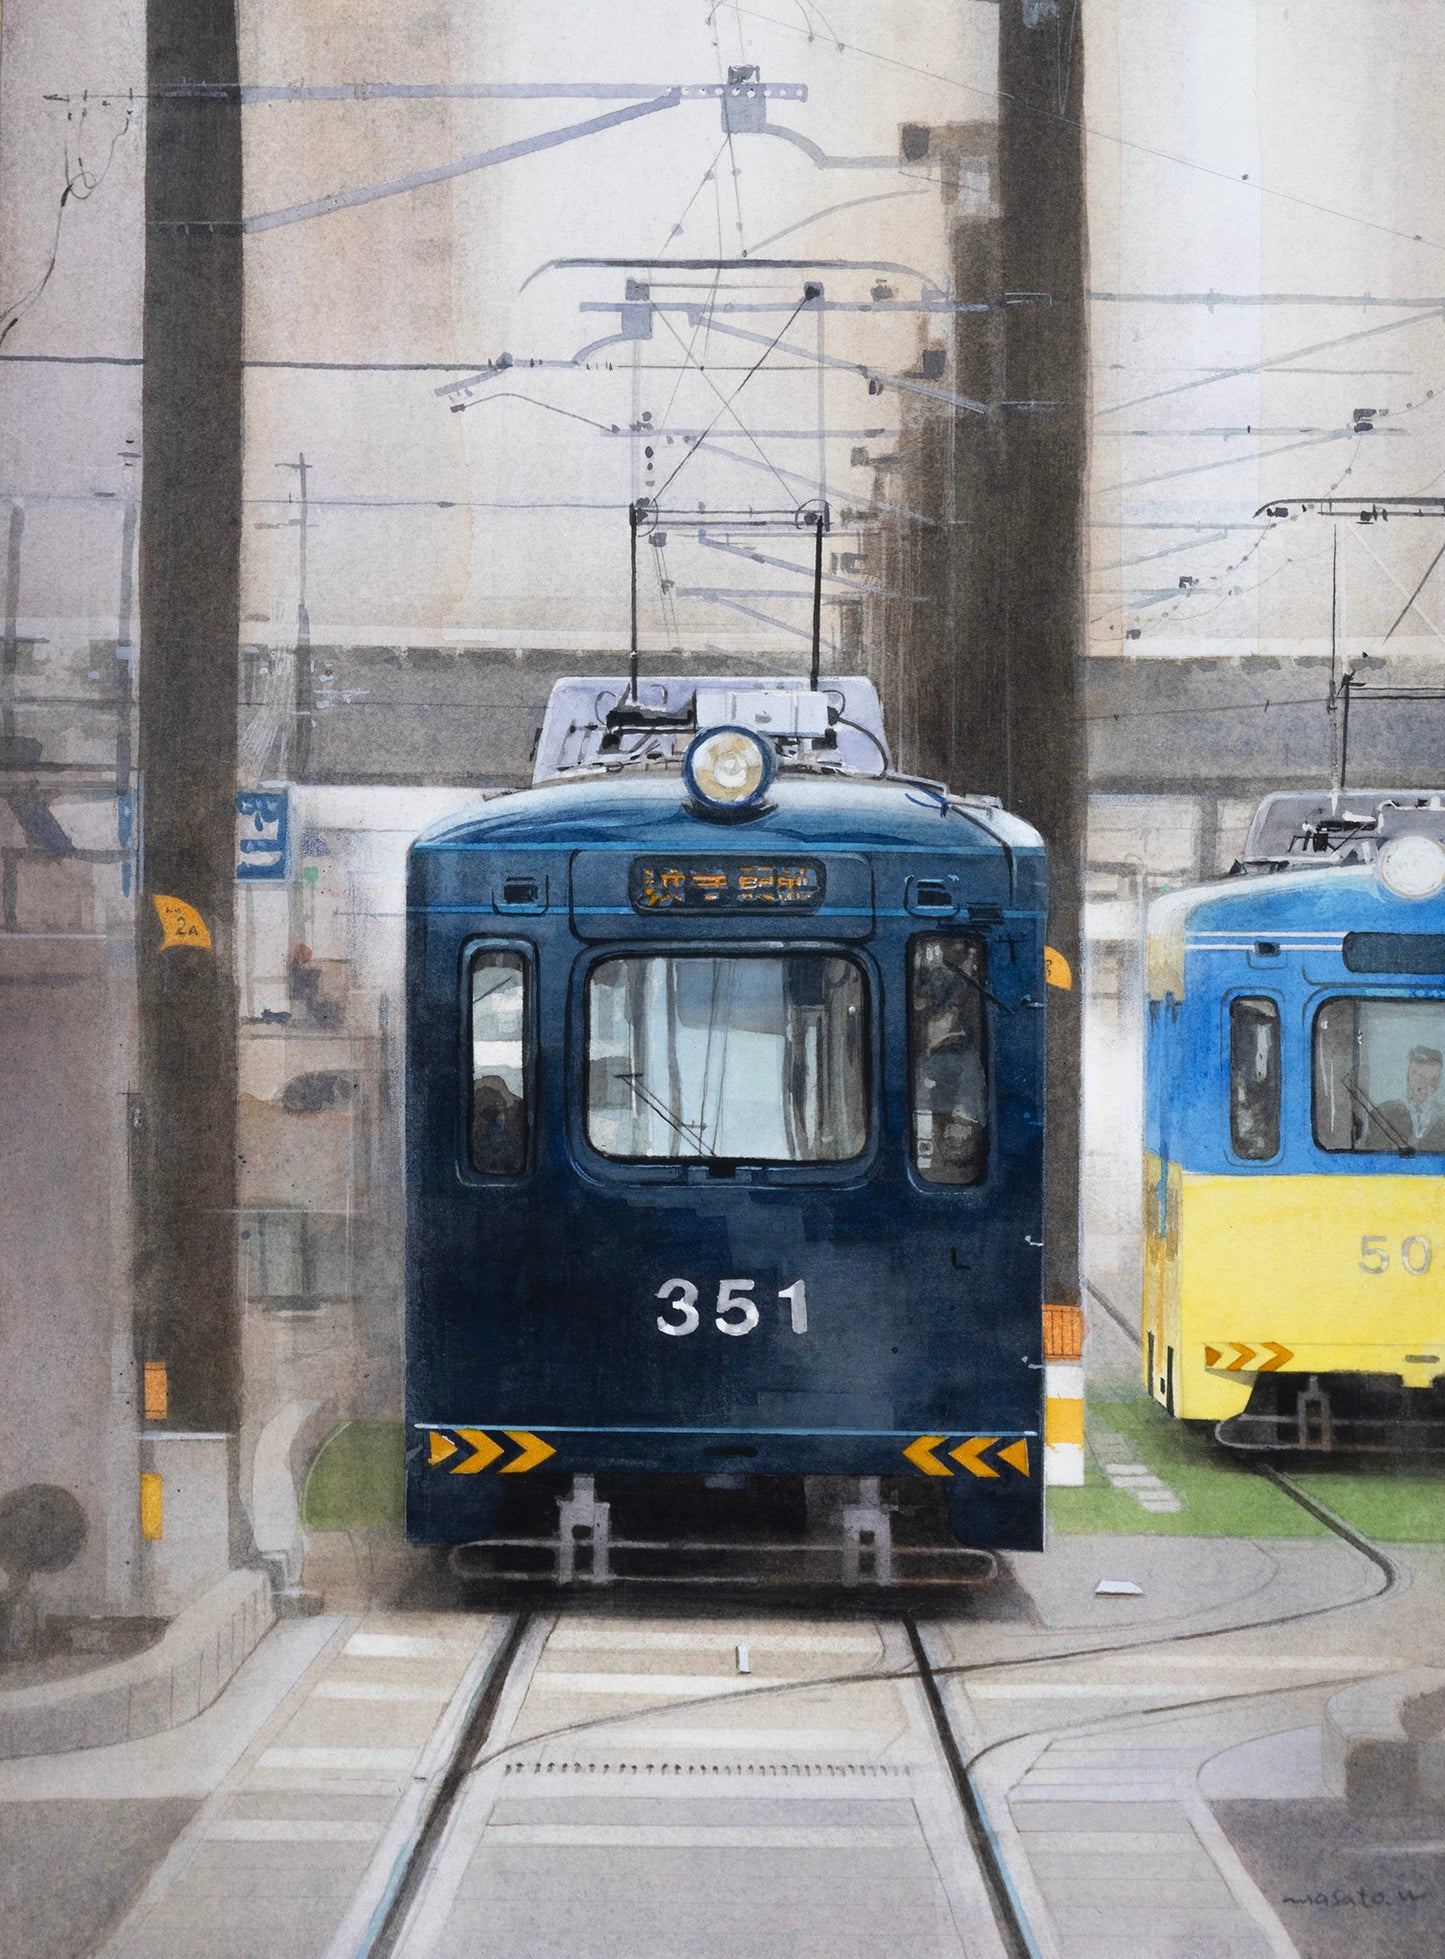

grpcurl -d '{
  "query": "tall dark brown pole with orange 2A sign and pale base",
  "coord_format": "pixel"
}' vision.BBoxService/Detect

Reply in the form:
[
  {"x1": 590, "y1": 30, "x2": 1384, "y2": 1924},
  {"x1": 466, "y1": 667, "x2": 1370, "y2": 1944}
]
[{"x1": 133, "y1": 0, "x2": 243, "y2": 1567}]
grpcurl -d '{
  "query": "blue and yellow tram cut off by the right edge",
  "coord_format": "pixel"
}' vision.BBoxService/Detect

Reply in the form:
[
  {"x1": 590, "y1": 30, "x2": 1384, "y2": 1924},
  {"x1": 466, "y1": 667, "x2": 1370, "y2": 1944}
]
[{"x1": 1143, "y1": 789, "x2": 1445, "y2": 1450}]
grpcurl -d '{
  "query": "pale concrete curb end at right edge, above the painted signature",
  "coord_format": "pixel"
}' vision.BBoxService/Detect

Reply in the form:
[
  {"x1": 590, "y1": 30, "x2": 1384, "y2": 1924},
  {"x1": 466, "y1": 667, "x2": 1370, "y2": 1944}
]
[{"x1": 1322, "y1": 1667, "x2": 1445, "y2": 1816}]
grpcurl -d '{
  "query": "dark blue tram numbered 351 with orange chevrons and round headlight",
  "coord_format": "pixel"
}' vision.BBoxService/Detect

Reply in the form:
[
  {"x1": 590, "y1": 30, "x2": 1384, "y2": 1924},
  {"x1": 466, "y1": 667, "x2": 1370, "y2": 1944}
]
[{"x1": 407, "y1": 680, "x2": 1046, "y2": 1548}]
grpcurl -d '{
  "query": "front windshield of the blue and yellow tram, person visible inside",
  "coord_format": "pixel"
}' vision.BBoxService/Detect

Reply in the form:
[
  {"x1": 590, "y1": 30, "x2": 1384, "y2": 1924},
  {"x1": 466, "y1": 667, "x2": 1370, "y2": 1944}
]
[{"x1": 1314, "y1": 999, "x2": 1445, "y2": 1156}]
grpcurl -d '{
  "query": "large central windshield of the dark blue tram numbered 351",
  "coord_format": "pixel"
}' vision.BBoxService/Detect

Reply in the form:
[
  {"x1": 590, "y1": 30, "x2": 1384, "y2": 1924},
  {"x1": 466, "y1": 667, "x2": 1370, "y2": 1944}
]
[{"x1": 587, "y1": 952, "x2": 867, "y2": 1164}]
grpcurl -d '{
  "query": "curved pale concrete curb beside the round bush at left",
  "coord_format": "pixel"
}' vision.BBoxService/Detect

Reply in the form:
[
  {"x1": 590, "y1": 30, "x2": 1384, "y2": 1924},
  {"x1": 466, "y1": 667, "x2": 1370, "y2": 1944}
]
[{"x1": 0, "y1": 1571, "x2": 276, "y2": 1761}]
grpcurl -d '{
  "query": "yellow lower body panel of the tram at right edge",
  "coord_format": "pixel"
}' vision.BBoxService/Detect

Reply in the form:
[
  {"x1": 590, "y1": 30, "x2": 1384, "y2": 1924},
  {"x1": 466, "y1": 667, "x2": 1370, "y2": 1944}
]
[{"x1": 1143, "y1": 1156, "x2": 1445, "y2": 1420}]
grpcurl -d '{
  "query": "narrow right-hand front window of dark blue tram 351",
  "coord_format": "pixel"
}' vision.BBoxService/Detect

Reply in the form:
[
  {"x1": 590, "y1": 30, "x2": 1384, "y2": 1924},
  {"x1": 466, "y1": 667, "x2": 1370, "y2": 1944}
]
[{"x1": 909, "y1": 934, "x2": 989, "y2": 1185}]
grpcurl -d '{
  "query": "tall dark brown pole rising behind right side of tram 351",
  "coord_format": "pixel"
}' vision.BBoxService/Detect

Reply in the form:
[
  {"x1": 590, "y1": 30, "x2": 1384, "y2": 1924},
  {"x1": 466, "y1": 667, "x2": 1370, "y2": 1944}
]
[{"x1": 936, "y1": 0, "x2": 1089, "y2": 1305}]
